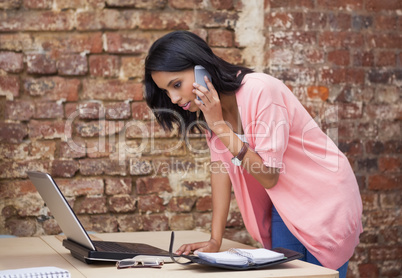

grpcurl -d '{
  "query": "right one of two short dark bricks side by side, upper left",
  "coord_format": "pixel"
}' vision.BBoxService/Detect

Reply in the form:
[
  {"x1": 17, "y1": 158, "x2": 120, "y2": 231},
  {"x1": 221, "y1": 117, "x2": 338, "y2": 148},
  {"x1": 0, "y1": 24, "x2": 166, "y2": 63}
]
[{"x1": 57, "y1": 54, "x2": 88, "y2": 75}]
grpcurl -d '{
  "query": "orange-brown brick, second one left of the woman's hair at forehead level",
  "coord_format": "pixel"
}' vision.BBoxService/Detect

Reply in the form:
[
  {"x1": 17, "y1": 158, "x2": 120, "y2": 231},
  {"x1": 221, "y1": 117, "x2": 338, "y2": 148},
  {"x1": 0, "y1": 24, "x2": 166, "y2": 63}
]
[{"x1": 24, "y1": 76, "x2": 81, "y2": 101}]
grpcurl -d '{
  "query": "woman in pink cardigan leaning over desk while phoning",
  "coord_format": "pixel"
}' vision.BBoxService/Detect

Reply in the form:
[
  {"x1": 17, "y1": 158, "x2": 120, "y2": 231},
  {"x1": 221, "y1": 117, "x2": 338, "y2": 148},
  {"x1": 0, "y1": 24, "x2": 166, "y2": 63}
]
[{"x1": 145, "y1": 31, "x2": 362, "y2": 277}]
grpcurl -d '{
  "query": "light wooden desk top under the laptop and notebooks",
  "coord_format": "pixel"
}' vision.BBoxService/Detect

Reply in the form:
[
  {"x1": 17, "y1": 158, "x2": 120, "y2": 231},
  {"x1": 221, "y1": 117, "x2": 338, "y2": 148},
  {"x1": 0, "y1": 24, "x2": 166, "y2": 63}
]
[{"x1": 0, "y1": 231, "x2": 338, "y2": 278}]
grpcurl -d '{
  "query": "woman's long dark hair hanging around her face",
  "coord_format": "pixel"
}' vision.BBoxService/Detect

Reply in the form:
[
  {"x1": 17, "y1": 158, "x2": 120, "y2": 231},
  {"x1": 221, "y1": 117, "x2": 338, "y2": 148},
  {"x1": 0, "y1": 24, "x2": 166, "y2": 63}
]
[{"x1": 145, "y1": 31, "x2": 253, "y2": 134}]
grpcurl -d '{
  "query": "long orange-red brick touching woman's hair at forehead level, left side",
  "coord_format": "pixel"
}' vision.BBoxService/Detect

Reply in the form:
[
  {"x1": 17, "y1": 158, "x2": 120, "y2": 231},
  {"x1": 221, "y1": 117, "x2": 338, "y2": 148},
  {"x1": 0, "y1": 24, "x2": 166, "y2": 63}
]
[{"x1": 82, "y1": 79, "x2": 143, "y2": 101}]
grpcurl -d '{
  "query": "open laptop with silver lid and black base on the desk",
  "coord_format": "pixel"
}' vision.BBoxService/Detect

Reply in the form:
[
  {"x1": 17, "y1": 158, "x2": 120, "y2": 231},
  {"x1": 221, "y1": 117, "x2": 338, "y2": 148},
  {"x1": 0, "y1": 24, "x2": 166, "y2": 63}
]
[{"x1": 27, "y1": 171, "x2": 170, "y2": 263}]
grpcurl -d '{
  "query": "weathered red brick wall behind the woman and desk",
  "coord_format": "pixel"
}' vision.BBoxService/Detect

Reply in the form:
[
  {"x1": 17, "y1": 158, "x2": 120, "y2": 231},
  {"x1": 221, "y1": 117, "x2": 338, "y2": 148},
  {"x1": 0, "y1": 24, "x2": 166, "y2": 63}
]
[{"x1": 0, "y1": 0, "x2": 402, "y2": 277}]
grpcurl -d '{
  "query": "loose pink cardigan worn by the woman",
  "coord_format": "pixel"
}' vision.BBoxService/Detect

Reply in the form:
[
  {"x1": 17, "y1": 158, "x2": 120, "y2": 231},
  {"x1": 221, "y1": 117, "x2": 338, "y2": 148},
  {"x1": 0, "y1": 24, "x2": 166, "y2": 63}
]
[{"x1": 207, "y1": 73, "x2": 363, "y2": 269}]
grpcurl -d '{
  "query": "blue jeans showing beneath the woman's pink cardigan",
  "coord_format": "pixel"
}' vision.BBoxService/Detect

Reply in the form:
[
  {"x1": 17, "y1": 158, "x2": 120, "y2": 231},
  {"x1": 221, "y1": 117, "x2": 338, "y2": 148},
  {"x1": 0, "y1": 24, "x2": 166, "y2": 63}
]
[{"x1": 272, "y1": 207, "x2": 348, "y2": 278}]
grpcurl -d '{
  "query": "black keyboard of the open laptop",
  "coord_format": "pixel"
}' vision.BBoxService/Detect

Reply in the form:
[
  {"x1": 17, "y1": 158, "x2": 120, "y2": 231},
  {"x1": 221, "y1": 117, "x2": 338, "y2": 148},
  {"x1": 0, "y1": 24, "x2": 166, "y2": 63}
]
[{"x1": 93, "y1": 241, "x2": 167, "y2": 254}]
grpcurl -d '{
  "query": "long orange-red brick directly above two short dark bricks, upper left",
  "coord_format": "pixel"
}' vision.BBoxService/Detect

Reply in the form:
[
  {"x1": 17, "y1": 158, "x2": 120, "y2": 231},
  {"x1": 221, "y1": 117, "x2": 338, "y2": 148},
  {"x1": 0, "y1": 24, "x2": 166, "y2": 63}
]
[{"x1": 32, "y1": 32, "x2": 103, "y2": 54}]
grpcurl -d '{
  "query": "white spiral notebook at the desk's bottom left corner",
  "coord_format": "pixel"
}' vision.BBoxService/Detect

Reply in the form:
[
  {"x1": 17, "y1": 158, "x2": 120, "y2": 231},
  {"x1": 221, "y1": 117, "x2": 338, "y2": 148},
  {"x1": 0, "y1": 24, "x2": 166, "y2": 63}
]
[{"x1": 0, "y1": 266, "x2": 71, "y2": 278}]
